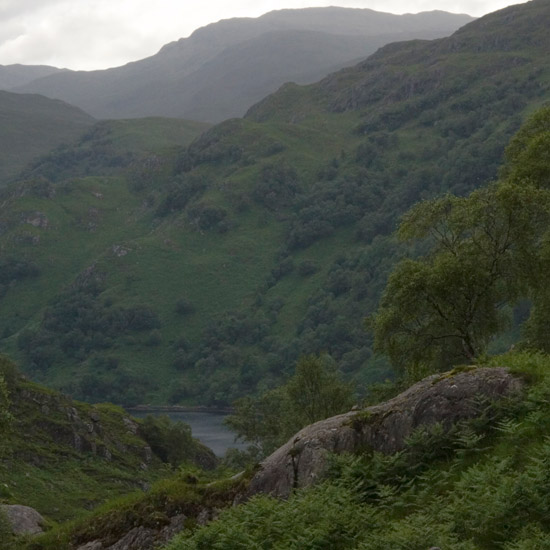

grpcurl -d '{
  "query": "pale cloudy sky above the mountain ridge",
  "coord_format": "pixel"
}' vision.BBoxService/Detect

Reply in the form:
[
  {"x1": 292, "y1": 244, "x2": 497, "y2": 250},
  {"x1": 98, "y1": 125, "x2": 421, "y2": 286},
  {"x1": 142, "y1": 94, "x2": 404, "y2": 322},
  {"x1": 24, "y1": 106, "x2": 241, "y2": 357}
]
[{"x1": 0, "y1": 0, "x2": 532, "y2": 70}]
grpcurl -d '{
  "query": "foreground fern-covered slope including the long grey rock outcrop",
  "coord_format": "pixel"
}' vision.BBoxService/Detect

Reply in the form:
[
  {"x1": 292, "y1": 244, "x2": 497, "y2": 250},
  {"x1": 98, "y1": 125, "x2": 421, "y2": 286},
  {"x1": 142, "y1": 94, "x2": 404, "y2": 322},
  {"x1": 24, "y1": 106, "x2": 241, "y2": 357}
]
[{"x1": 20, "y1": 354, "x2": 550, "y2": 550}]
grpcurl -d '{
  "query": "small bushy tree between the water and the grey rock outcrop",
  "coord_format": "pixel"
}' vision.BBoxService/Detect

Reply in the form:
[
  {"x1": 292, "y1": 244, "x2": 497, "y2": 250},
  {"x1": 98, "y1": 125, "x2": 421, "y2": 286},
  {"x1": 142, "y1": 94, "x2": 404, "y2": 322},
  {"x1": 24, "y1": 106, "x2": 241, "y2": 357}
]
[{"x1": 226, "y1": 355, "x2": 353, "y2": 457}]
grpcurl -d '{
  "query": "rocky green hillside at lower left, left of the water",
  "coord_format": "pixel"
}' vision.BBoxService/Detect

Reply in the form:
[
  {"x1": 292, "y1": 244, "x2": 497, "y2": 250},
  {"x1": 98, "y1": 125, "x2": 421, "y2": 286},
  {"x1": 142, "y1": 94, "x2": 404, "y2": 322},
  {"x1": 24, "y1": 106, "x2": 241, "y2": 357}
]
[{"x1": 0, "y1": 356, "x2": 217, "y2": 537}]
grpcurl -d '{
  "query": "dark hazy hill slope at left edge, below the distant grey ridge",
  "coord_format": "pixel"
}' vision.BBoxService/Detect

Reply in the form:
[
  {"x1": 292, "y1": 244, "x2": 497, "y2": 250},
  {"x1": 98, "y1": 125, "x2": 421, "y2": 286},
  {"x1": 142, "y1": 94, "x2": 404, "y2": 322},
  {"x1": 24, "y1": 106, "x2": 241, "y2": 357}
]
[{"x1": 0, "y1": 91, "x2": 94, "y2": 181}]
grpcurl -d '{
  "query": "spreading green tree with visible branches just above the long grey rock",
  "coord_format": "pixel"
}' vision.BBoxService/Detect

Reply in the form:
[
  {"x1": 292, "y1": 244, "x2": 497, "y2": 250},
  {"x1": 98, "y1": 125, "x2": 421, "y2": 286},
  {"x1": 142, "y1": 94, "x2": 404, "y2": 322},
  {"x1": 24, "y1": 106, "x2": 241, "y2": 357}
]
[{"x1": 372, "y1": 182, "x2": 550, "y2": 378}]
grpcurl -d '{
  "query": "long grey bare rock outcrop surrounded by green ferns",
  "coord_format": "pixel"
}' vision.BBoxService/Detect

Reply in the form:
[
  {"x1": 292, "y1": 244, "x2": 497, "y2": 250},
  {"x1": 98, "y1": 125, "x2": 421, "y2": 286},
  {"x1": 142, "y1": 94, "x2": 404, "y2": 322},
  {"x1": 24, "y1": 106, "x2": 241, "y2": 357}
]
[{"x1": 247, "y1": 368, "x2": 523, "y2": 498}]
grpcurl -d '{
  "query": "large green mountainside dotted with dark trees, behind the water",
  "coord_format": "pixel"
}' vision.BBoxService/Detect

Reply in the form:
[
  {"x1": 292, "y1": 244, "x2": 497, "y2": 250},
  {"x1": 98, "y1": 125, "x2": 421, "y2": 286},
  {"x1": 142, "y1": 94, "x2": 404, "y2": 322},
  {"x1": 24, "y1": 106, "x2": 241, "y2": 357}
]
[{"x1": 0, "y1": 0, "x2": 550, "y2": 406}]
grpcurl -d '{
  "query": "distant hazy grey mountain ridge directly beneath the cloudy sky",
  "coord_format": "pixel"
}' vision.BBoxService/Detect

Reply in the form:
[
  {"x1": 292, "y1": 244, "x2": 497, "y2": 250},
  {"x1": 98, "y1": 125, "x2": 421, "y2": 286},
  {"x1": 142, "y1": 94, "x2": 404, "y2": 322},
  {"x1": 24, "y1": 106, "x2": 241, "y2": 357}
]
[{"x1": 8, "y1": 8, "x2": 472, "y2": 122}]
